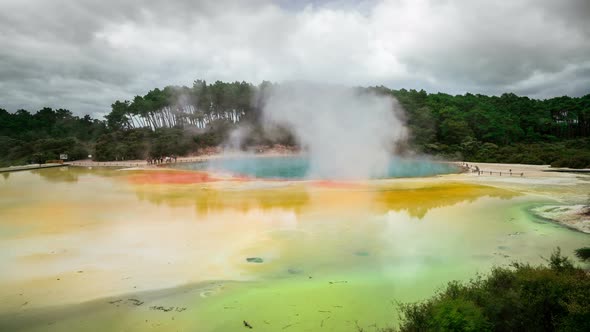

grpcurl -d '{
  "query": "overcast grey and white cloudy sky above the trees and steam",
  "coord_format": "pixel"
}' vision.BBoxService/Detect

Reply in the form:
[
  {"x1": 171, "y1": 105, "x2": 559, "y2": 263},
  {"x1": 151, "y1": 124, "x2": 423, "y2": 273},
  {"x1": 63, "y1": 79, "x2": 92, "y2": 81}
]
[{"x1": 0, "y1": 0, "x2": 590, "y2": 115}]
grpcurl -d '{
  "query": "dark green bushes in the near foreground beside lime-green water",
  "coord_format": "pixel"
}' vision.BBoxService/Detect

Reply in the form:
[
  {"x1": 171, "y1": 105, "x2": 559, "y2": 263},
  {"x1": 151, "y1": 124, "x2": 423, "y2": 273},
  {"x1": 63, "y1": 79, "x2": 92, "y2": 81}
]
[{"x1": 385, "y1": 248, "x2": 590, "y2": 332}]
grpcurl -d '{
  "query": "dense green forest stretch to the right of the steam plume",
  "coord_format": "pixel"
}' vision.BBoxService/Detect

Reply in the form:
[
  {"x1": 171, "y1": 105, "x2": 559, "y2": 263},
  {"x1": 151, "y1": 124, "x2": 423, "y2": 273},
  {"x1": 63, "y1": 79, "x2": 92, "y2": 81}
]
[{"x1": 388, "y1": 88, "x2": 590, "y2": 168}]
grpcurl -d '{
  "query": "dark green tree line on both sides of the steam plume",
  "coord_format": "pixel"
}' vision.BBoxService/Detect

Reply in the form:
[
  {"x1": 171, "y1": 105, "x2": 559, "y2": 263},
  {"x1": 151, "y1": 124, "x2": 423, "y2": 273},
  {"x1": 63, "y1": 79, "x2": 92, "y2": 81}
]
[{"x1": 0, "y1": 80, "x2": 590, "y2": 168}]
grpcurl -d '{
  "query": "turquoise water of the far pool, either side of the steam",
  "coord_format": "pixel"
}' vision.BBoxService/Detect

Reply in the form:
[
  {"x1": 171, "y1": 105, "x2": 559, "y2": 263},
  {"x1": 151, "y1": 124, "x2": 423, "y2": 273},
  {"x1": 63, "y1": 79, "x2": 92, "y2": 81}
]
[{"x1": 175, "y1": 156, "x2": 458, "y2": 179}]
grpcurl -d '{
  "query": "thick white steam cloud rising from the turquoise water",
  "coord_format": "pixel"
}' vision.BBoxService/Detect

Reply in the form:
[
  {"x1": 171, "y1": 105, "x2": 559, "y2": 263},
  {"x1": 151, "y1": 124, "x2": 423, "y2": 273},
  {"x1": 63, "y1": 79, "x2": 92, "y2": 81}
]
[{"x1": 263, "y1": 82, "x2": 407, "y2": 179}]
